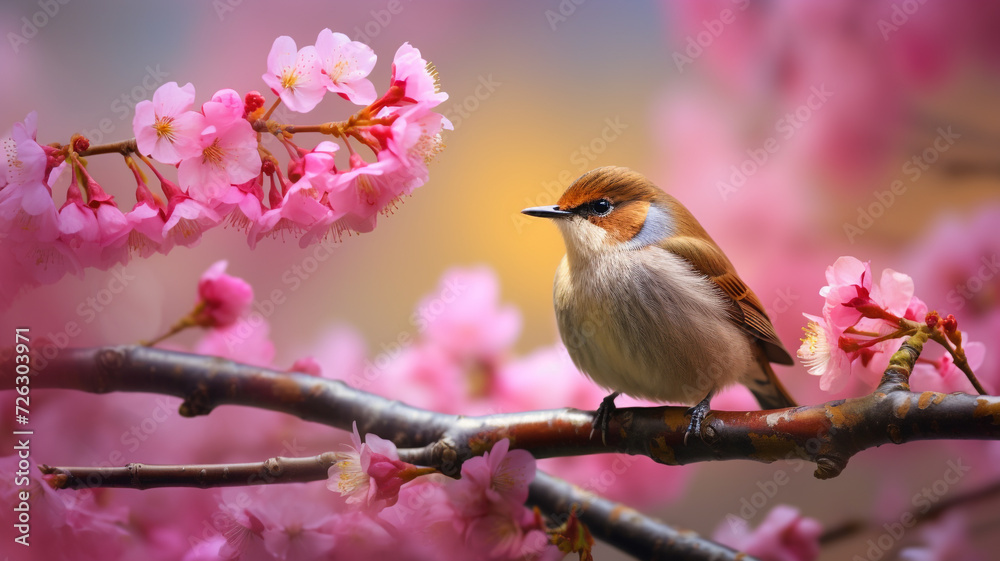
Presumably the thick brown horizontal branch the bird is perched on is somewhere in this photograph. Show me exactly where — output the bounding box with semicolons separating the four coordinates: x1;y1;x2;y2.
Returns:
11;341;1000;478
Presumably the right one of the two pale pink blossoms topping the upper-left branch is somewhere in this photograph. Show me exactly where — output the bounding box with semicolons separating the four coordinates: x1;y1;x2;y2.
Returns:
316;29;376;105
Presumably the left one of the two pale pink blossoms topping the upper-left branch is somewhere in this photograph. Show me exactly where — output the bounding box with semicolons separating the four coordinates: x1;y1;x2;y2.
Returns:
261;35;327;113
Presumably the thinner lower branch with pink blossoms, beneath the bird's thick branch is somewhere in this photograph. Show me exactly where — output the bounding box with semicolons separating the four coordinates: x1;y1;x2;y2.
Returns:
40;442;756;561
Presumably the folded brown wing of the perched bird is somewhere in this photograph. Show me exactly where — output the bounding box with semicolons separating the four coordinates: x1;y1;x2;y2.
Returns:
658;237;795;364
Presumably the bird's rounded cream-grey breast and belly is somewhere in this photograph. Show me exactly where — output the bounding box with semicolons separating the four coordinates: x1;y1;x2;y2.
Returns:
554;245;752;403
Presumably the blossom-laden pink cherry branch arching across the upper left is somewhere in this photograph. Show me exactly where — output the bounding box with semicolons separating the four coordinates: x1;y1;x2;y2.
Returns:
0;29;451;306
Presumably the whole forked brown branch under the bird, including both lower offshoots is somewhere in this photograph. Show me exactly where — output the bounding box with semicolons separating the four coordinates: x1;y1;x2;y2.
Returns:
7;335;1000;559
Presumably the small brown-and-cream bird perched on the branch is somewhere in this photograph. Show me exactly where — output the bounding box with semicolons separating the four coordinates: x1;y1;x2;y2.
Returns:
521;166;795;443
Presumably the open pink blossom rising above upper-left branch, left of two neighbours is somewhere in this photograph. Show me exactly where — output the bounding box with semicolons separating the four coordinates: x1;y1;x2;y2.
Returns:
132;82;201;164
